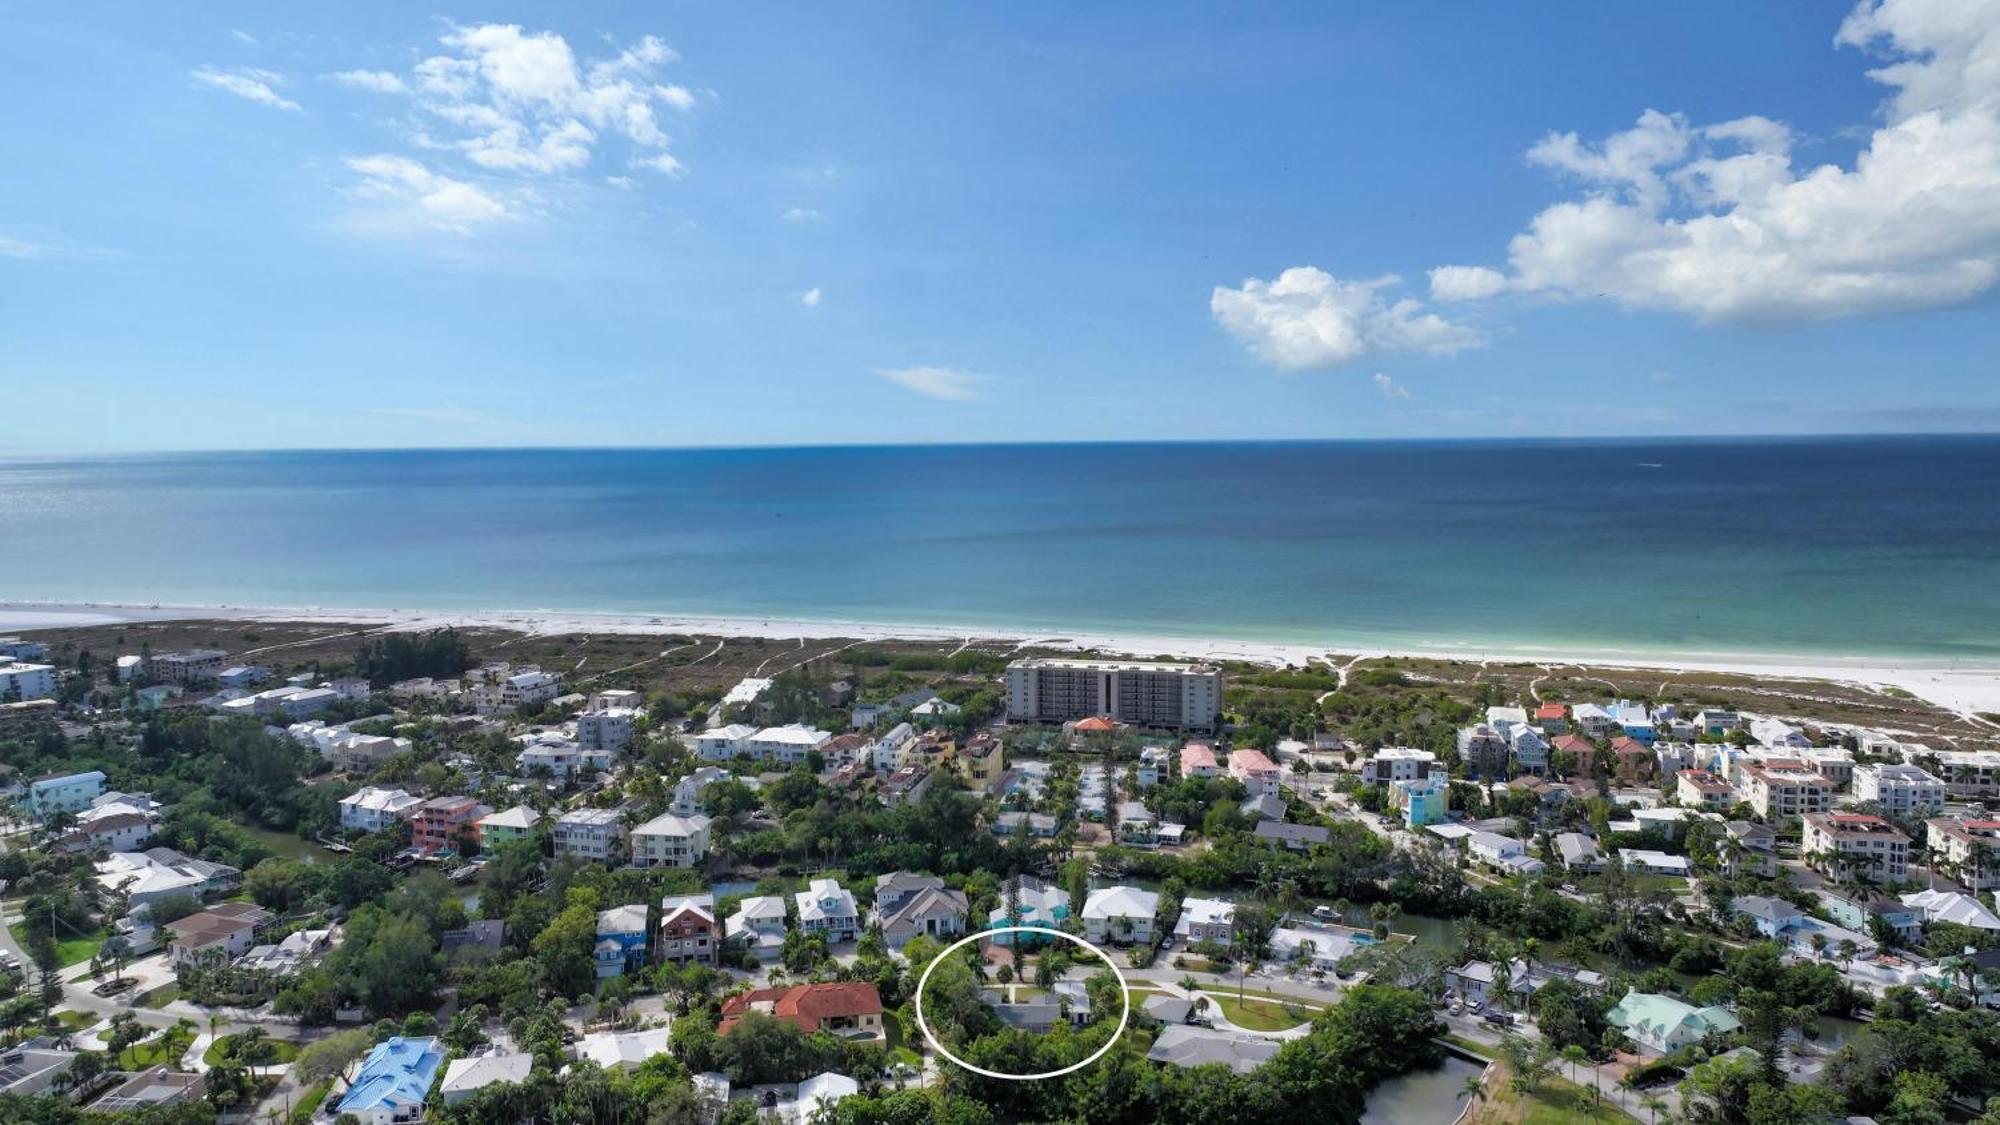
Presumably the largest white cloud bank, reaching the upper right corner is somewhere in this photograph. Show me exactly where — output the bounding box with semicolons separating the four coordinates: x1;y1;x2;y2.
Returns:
1432;0;2000;324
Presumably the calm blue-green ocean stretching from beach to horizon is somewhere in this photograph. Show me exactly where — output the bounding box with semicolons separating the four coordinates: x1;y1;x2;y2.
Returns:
0;436;2000;663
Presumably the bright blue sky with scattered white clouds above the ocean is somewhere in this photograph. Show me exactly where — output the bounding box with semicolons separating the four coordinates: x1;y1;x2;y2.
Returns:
0;0;2000;452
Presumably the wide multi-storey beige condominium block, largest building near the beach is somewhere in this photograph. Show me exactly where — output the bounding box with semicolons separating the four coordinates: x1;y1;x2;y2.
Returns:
1006;657;1222;731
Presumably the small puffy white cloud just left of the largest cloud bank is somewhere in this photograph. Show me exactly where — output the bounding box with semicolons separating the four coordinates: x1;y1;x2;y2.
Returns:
1208;266;1482;370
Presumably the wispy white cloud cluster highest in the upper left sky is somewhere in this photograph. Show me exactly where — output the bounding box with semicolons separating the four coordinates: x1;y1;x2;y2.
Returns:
380;24;694;176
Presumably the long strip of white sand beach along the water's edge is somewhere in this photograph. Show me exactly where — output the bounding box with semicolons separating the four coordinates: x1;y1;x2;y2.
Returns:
0;601;2000;719
